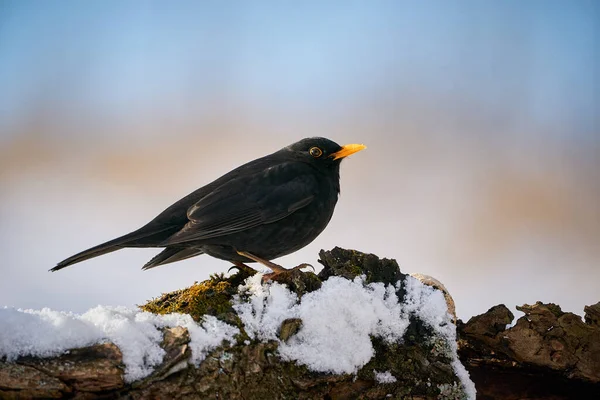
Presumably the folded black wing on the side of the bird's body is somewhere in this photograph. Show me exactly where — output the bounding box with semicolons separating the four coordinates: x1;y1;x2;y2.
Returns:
162;163;318;245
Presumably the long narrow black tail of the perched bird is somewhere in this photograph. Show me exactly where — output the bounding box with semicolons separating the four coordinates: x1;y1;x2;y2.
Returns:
50;227;176;272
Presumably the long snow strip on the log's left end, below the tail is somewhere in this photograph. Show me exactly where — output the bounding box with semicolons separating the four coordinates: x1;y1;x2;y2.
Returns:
0;306;239;382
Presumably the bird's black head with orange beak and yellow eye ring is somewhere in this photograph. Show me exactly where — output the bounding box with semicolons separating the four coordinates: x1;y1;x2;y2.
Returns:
285;137;367;168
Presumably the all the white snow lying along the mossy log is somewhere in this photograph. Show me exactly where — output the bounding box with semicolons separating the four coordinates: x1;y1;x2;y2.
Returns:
0;274;475;399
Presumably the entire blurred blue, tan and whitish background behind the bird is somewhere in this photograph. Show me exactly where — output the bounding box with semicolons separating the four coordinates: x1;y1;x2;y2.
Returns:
0;0;600;319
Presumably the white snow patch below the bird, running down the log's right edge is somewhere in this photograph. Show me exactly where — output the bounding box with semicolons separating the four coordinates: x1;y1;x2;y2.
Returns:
234;274;475;399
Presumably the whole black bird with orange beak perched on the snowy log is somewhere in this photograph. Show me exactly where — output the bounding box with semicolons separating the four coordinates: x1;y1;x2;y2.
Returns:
51;137;365;274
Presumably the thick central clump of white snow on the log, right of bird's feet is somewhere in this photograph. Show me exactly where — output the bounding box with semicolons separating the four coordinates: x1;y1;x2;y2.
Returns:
279;277;408;374
